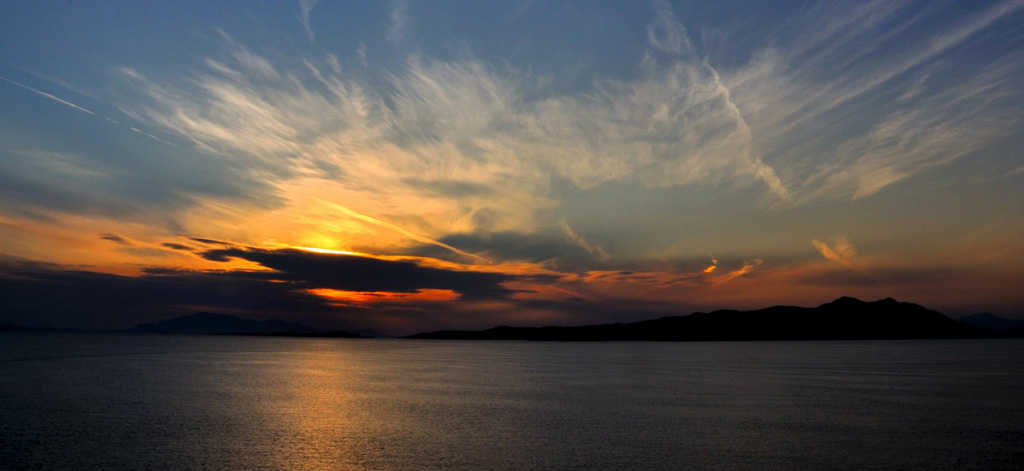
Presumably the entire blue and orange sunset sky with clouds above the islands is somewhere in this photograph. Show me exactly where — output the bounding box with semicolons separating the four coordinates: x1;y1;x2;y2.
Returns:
0;0;1024;334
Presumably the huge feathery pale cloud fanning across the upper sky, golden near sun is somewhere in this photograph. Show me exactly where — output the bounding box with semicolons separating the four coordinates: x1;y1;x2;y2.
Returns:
105;2;1020;273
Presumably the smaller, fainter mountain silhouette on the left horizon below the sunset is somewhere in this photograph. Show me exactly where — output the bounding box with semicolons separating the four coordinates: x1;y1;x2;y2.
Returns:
128;312;324;335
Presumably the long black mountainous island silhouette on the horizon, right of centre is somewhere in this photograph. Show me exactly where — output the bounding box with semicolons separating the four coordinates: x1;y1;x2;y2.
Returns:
409;297;983;342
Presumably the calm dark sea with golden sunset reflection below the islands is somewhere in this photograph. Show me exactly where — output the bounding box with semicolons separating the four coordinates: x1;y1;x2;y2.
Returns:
0;334;1024;470
